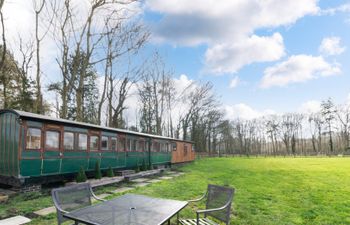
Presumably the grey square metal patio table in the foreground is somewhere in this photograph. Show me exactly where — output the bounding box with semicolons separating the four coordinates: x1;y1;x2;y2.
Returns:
64;194;188;225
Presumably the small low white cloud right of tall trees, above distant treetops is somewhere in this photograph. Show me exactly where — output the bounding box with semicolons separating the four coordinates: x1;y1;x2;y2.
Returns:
223;103;275;120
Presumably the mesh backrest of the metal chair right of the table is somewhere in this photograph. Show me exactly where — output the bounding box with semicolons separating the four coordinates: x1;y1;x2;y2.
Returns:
205;184;235;224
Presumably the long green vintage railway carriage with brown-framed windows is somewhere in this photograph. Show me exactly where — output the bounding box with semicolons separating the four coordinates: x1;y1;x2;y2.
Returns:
0;109;192;186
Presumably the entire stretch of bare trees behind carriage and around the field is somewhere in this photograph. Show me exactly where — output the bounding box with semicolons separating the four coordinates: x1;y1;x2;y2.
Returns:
0;0;350;156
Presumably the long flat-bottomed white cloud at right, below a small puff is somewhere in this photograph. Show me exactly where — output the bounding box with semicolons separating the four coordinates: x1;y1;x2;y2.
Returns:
260;55;341;88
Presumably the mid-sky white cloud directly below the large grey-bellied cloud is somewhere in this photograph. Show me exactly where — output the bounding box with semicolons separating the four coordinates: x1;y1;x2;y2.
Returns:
205;33;285;74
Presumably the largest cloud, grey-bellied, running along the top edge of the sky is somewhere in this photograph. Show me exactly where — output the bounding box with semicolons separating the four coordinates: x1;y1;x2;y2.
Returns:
146;0;319;45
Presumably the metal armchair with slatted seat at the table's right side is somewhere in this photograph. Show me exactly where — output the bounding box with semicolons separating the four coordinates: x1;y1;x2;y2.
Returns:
178;184;235;225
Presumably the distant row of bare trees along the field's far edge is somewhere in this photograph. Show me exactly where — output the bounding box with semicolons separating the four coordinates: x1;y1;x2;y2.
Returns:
216;99;350;156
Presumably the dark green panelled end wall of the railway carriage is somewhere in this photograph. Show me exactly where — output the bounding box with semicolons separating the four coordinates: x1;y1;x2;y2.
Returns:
0;113;20;177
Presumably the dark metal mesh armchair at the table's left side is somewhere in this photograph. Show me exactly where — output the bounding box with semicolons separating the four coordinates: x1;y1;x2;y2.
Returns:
51;183;105;225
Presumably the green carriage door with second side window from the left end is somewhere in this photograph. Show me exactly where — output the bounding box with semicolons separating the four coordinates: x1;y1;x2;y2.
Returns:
41;124;62;175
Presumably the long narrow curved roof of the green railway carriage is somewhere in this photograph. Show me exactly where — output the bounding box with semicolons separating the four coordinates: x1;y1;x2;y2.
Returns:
0;109;193;143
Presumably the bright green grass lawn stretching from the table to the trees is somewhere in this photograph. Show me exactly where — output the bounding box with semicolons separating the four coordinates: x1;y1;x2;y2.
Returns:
0;158;350;225
